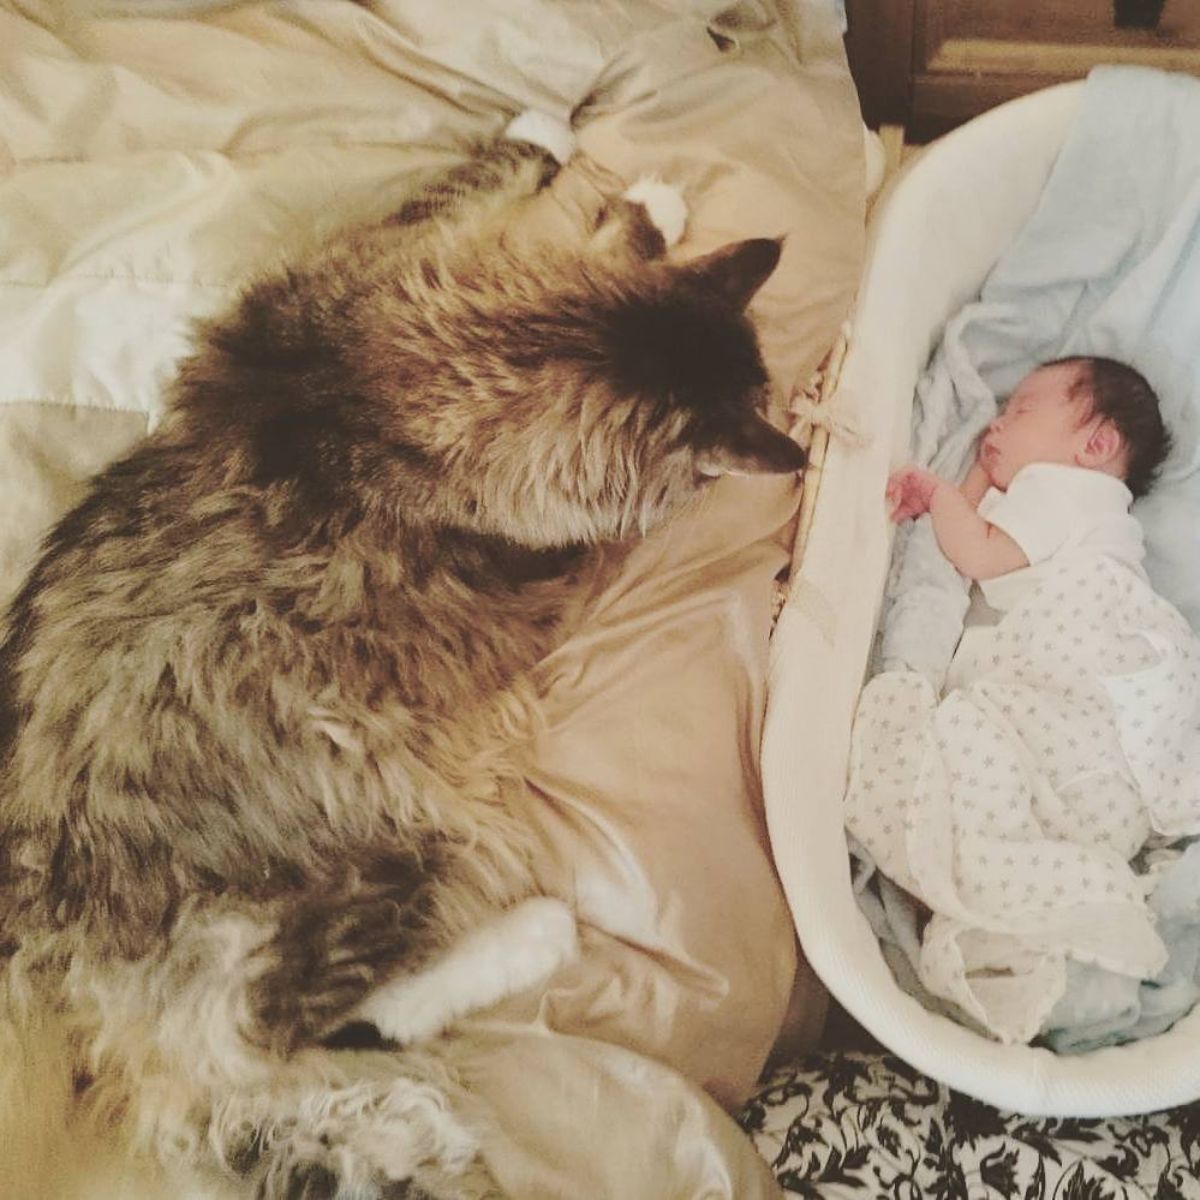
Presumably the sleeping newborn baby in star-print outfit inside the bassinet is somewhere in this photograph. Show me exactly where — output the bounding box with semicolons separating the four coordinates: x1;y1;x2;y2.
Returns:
847;358;1200;1042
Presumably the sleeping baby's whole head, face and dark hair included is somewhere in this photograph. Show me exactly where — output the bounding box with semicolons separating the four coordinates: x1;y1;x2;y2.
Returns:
979;358;1171;497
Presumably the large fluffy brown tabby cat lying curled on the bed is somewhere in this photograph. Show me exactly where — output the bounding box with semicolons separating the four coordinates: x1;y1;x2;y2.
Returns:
0;114;803;1200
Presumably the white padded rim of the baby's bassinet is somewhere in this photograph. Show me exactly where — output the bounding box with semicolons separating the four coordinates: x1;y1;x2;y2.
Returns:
763;84;1200;1116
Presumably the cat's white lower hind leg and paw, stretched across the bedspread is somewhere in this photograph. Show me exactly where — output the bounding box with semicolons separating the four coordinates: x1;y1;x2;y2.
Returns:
355;896;578;1045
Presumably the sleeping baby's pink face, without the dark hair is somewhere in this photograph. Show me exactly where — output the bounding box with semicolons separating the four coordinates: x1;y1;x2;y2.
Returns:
979;362;1091;491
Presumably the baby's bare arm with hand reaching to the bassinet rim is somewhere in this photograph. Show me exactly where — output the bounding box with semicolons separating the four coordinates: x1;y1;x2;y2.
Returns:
887;467;1030;580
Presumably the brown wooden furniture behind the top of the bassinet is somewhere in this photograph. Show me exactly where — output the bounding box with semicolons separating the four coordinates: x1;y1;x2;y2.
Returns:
846;0;1200;142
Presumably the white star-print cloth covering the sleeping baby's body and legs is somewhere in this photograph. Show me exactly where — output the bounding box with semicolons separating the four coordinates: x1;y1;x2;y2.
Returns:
846;554;1200;1042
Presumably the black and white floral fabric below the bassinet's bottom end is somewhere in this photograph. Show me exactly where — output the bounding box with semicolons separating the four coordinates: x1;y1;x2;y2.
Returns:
740;1051;1200;1200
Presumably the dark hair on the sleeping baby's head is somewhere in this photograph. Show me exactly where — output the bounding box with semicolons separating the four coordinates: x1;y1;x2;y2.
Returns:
1043;355;1171;497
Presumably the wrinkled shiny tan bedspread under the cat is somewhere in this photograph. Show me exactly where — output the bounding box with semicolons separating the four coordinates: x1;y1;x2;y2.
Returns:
0;0;863;1200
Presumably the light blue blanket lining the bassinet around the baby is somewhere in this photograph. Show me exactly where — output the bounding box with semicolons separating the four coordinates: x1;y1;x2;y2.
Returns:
869;67;1200;1051
